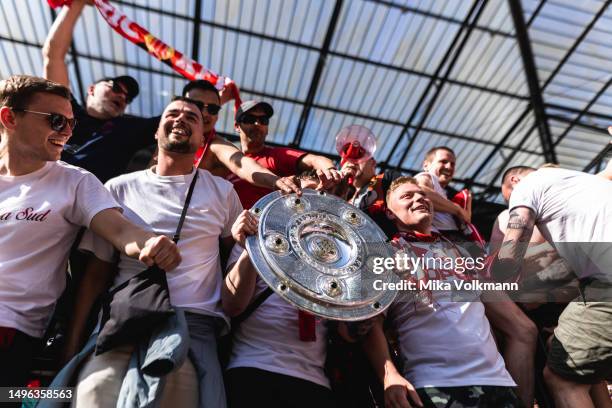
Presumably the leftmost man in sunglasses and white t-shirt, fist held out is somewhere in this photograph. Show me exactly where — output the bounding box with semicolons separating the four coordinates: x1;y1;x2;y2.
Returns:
0;75;180;386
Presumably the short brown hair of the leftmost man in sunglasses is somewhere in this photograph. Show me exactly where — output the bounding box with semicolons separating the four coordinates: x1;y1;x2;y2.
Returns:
0;75;70;109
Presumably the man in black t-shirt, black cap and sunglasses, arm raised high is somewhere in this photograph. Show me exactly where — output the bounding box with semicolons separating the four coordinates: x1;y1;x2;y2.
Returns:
43;0;159;182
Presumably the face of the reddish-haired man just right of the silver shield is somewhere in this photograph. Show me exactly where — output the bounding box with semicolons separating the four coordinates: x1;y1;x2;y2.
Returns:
387;183;433;230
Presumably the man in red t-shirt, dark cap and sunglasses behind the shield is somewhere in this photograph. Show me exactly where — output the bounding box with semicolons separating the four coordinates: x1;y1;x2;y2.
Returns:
228;100;342;208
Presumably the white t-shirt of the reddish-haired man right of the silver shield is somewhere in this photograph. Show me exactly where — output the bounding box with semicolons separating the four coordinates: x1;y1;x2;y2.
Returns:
387;237;515;388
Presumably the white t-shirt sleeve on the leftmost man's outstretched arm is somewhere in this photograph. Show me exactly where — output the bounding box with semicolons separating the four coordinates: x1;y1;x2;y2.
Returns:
67;172;121;228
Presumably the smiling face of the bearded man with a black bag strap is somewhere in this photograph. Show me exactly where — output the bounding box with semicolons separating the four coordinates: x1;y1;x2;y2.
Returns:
155;101;204;154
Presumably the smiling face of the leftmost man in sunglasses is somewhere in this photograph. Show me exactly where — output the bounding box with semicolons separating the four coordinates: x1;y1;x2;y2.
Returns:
6;92;74;162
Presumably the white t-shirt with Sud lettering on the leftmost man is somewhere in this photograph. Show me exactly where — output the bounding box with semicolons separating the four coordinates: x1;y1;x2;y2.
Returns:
0;161;118;337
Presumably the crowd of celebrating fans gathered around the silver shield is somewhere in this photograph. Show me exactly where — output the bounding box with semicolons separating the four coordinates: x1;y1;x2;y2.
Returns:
0;1;612;408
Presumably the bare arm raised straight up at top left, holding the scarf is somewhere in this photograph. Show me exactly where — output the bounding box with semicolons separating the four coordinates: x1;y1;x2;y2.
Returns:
42;0;87;87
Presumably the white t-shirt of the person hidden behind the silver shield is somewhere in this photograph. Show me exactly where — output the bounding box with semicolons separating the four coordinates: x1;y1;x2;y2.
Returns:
228;251;330;388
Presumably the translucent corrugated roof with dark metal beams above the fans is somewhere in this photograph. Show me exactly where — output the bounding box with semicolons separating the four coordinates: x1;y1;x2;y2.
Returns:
0;0;612;201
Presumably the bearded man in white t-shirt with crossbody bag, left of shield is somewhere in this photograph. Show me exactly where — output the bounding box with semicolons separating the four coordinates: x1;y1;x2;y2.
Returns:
68;97;242;408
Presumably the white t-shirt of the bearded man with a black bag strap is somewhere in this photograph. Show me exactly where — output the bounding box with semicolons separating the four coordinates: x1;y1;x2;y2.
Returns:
80;170;242;322
